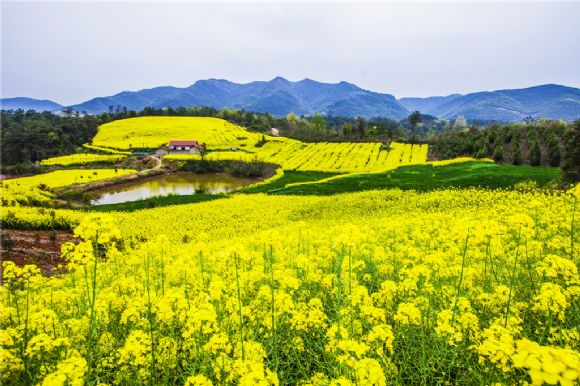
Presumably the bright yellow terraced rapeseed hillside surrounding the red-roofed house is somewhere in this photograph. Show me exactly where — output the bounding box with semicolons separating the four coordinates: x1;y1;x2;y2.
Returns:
93;117;428;173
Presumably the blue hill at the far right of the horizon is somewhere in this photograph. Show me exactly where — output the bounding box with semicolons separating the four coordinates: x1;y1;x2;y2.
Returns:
399;84;580;122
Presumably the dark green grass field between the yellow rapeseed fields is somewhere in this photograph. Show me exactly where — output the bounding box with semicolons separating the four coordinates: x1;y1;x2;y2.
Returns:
260;161;560;195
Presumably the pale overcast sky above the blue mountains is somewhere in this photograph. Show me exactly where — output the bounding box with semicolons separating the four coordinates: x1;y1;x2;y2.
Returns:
1;1;580;104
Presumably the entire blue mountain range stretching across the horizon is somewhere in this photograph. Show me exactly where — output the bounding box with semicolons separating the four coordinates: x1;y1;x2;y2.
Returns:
0;77;580;122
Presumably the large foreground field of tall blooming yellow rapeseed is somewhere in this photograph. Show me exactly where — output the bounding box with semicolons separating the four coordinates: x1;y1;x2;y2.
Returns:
0;189;580;386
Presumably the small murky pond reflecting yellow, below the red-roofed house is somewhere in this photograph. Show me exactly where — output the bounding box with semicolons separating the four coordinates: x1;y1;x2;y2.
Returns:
90;173;259;205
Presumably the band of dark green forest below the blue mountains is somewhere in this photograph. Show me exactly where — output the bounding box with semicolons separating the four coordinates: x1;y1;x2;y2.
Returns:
1;106;580;181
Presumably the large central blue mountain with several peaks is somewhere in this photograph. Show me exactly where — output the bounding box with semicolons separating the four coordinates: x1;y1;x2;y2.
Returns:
72;77;408;119
